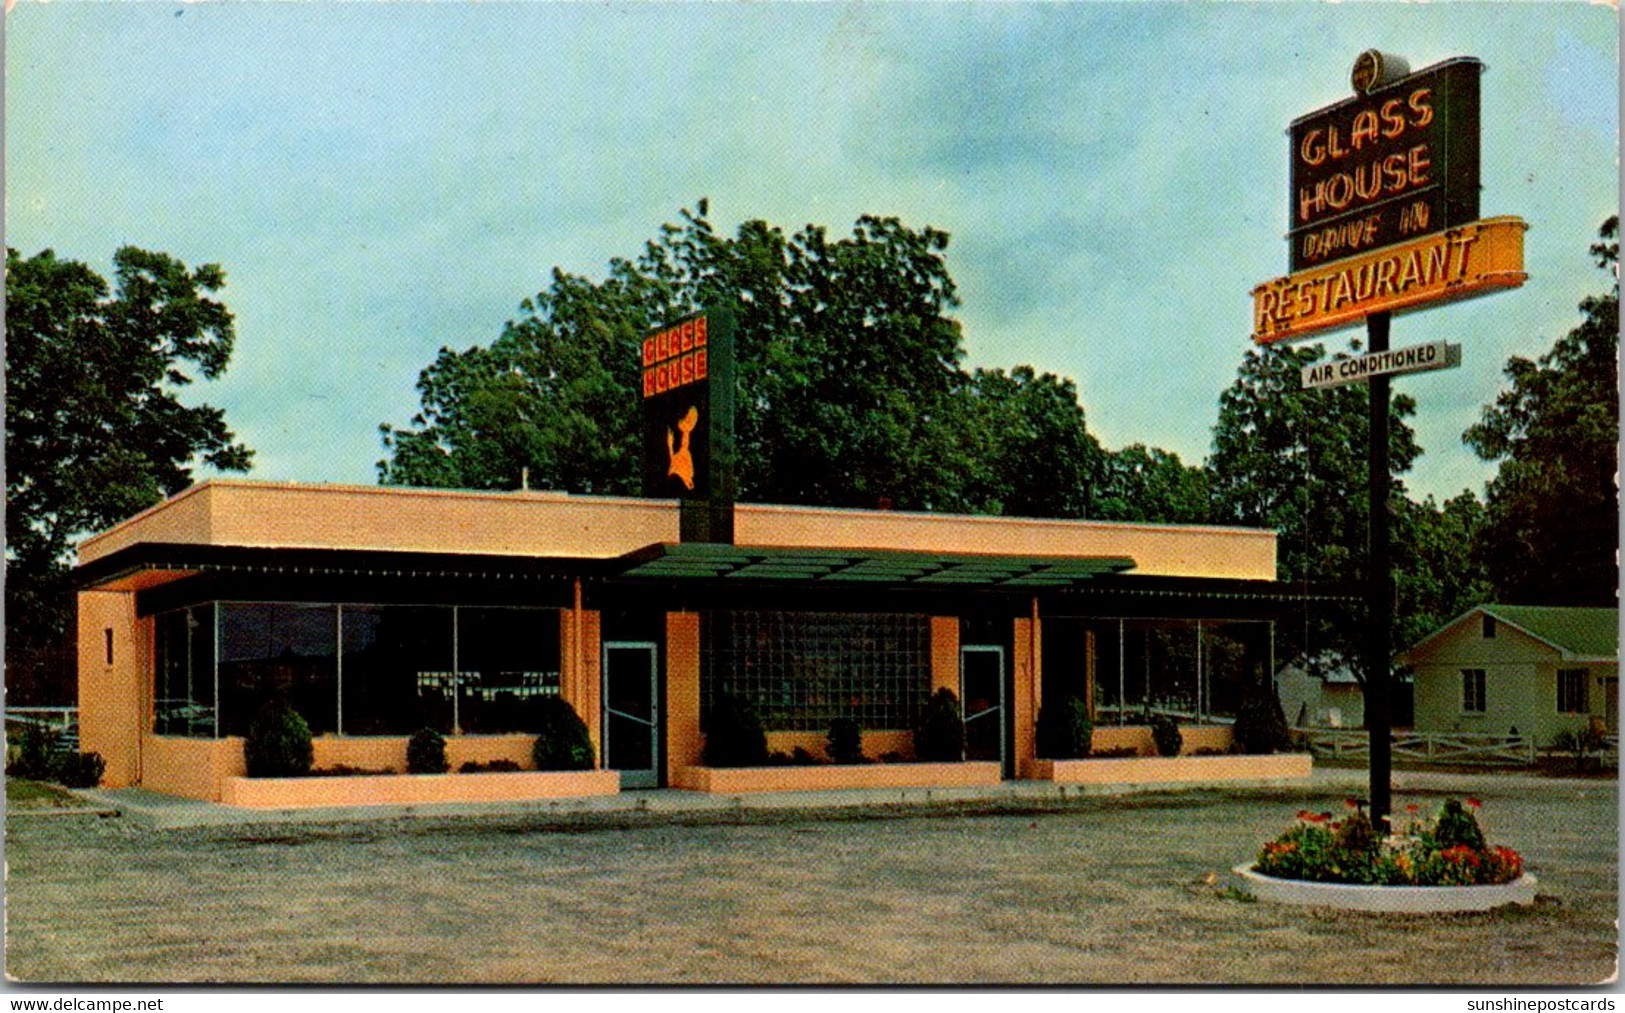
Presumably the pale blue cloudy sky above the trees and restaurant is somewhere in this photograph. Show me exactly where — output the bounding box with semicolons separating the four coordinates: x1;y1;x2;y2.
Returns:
5;0;1619;498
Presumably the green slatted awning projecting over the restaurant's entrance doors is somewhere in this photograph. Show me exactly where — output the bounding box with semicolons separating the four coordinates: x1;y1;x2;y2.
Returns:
616;541;1134;589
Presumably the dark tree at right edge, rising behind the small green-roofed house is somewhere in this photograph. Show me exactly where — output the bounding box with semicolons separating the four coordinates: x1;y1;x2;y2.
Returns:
1463;216;1620;606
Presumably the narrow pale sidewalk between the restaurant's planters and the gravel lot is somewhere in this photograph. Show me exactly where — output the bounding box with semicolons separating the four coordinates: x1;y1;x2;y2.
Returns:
60;767;1586;829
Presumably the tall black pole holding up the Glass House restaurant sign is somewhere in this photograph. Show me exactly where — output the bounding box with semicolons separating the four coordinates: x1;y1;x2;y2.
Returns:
1365;311;1394;833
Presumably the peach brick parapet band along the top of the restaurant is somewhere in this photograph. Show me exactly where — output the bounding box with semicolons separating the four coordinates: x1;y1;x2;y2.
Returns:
80;480;1276;580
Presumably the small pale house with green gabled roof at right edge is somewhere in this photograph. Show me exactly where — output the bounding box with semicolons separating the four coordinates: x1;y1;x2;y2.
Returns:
1398;605;1619;746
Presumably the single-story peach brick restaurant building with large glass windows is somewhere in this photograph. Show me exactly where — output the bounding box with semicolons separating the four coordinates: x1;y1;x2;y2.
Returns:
76;480;1332;800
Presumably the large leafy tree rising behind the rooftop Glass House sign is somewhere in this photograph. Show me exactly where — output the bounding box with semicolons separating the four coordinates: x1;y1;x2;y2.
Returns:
379;202;977;509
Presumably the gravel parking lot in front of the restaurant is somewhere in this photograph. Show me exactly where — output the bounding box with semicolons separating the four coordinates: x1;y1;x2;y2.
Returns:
7;776;1619;985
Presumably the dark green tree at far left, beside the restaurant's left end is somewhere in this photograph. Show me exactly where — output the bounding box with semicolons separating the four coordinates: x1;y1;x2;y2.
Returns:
5;247;252;702
